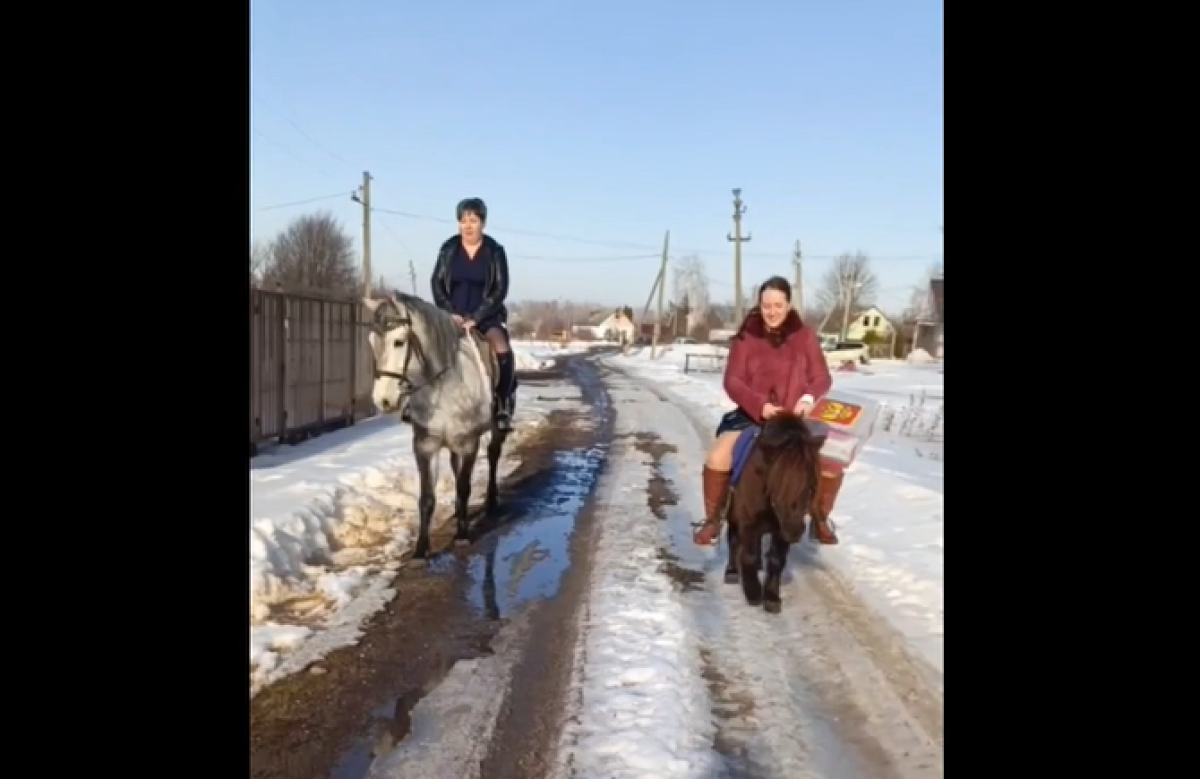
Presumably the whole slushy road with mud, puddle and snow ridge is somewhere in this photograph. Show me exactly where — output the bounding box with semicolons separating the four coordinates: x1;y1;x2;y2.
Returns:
251;356;943;779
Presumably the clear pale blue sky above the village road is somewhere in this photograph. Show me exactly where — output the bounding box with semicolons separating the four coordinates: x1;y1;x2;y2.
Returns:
251;0;944;308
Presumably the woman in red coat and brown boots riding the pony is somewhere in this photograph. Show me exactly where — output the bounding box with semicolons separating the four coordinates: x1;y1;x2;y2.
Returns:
695;276;841;545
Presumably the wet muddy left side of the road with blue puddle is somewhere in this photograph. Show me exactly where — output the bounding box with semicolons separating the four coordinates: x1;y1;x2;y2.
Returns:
250;356;612;779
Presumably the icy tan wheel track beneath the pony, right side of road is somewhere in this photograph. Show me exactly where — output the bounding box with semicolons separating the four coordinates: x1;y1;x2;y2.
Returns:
604;368;944;779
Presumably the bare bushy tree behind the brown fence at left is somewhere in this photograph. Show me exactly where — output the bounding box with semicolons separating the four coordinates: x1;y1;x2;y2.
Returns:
263;211;362;298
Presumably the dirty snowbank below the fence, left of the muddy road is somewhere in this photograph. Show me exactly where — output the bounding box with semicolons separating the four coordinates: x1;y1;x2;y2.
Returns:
250;403;556;691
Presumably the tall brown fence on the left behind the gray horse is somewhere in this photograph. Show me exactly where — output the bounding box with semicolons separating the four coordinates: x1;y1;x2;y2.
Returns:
250;289;374;456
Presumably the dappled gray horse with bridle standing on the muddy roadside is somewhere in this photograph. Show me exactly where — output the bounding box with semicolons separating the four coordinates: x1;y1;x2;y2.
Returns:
364;292;508;559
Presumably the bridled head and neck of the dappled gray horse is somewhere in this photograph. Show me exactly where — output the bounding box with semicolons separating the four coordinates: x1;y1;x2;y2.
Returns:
362;292;460;413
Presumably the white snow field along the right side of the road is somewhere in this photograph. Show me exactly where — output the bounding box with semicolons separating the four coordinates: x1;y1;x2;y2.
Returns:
607;346;944;670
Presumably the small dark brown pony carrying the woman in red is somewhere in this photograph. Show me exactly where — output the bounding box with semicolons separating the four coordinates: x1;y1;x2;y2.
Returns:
725;413;827;615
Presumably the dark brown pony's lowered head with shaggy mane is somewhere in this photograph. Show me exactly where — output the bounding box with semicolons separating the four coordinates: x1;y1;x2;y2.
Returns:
757;413;824;544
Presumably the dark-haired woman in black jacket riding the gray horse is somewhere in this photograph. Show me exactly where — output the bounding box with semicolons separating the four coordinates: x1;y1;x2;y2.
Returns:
431;198;516;431
